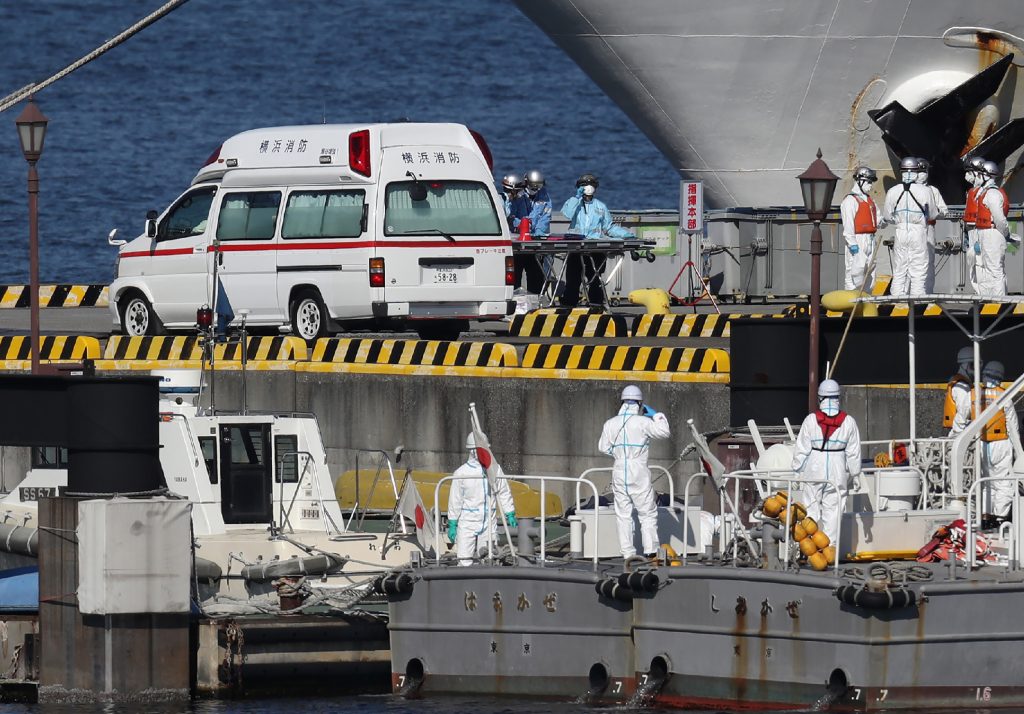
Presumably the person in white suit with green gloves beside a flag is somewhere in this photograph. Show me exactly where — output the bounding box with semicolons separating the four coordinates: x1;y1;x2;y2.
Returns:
449;431;519;565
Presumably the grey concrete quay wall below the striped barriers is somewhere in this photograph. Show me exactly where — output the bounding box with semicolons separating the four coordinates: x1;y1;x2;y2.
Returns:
209;372;729;505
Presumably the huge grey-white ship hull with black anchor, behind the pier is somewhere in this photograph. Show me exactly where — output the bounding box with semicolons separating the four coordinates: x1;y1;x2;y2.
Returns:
515;0;1024;208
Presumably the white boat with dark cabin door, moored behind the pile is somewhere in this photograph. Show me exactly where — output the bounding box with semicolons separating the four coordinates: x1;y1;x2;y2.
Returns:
0;370;418;600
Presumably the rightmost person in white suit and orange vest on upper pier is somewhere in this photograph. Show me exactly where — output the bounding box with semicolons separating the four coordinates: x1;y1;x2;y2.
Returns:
974;161;1017;295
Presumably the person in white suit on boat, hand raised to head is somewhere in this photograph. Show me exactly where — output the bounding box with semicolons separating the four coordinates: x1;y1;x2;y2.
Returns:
597;384;671;558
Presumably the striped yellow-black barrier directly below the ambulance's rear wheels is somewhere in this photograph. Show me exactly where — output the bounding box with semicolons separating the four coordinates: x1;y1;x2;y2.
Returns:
310;338;519;367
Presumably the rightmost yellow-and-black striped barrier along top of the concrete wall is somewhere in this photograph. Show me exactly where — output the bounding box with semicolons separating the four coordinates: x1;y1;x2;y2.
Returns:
522;344;729;374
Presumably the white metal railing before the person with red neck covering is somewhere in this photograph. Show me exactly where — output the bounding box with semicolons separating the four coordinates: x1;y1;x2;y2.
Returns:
682;469;843;569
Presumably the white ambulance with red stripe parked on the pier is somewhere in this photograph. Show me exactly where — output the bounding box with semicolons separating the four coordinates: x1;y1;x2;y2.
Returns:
110;123;515;339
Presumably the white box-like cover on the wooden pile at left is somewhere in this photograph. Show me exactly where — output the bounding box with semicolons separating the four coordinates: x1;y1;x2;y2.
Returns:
78;498;191;615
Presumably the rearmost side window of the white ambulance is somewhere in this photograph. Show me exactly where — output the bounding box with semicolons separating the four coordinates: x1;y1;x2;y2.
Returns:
281;188;367;240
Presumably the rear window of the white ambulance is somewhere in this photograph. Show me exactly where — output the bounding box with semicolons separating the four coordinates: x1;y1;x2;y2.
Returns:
384;179;502;236
